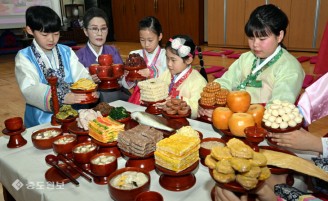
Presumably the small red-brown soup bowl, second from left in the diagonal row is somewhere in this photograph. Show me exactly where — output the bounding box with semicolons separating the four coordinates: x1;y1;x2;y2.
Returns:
52;134;77;154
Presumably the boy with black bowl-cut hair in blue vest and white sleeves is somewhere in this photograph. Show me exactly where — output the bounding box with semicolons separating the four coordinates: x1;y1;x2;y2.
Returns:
15;6;92;128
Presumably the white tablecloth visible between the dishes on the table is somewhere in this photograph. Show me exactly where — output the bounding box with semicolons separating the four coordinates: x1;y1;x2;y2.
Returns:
0;101;316;201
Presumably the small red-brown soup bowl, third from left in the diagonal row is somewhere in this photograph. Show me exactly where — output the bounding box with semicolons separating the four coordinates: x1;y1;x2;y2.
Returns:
72;142;98;164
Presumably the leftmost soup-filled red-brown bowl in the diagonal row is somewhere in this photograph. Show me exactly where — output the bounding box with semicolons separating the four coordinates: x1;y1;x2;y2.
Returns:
31;128;63;149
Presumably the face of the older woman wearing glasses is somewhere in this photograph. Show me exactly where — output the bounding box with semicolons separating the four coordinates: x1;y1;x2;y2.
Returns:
83;17;108;49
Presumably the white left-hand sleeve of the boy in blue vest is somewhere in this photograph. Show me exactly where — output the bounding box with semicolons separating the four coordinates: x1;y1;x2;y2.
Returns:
15;53;51;111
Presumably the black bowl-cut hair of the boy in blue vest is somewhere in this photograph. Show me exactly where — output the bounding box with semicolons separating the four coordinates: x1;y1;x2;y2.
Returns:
25;6;61;33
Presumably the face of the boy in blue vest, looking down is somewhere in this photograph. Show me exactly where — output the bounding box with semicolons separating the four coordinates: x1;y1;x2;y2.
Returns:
26;28;60;51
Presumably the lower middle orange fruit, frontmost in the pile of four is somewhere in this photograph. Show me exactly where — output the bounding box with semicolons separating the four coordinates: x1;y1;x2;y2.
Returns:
228;112;255;137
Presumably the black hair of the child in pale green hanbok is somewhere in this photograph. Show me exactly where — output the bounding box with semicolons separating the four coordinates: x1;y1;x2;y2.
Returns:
245;4;288;48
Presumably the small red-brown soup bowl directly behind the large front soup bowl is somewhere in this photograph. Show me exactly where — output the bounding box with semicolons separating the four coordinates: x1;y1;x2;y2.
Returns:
90;152;117;176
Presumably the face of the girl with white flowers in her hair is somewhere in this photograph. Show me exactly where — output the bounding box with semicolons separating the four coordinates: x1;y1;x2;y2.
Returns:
166;48;193;75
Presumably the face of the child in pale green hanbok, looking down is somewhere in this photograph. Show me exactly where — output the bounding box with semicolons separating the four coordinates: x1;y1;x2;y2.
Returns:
248;31;284;59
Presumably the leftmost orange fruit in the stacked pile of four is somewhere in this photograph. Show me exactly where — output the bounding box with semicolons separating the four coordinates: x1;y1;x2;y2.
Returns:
212;107;233;130
